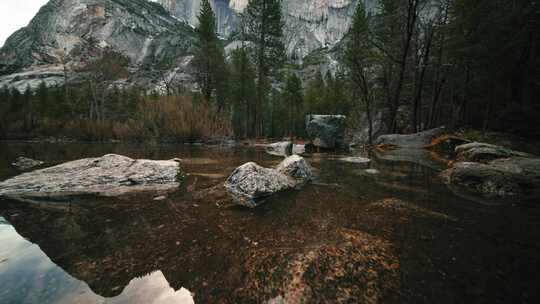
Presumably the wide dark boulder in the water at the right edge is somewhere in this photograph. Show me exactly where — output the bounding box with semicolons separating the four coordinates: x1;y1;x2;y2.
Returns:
443;157;540;200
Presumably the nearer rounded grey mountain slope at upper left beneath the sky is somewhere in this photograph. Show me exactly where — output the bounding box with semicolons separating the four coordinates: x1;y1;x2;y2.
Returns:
0;0;193;87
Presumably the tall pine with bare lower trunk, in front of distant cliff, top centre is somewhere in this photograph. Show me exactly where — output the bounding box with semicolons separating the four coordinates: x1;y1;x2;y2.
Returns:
241;0;285;136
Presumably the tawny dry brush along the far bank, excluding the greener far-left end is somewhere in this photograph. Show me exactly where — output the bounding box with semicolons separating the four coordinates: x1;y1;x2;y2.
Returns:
57;96;232;142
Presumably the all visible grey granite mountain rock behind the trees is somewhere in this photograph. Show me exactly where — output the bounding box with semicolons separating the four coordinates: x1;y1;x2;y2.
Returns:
0;0;376;91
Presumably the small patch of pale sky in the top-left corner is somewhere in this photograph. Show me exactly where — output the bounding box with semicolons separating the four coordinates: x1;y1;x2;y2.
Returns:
0;0;47;46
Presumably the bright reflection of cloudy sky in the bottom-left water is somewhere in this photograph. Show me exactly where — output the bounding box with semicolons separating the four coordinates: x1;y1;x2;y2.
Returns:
0;217;193;304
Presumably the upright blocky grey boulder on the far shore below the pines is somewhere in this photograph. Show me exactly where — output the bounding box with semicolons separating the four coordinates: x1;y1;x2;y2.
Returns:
306;115;347;149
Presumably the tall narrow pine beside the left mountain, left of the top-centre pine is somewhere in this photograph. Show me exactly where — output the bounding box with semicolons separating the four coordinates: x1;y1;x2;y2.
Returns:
193;0;227;110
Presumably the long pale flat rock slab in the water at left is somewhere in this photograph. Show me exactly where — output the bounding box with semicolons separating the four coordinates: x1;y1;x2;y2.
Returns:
0;154;180;199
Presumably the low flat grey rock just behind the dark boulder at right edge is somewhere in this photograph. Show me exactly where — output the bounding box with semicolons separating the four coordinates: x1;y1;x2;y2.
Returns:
455;142;531;163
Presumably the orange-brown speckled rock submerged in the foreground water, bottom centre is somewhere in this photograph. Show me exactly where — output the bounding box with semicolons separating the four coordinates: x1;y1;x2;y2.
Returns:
236;228;400;304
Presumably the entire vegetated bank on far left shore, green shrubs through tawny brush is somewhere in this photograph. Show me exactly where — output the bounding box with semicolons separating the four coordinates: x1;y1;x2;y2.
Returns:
0;89;232;142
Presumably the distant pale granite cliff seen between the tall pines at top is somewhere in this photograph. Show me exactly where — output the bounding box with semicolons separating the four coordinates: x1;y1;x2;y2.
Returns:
158;0;376;59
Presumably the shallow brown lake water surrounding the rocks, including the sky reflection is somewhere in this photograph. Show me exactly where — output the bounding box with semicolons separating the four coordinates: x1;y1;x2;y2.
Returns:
0;142;540;303
